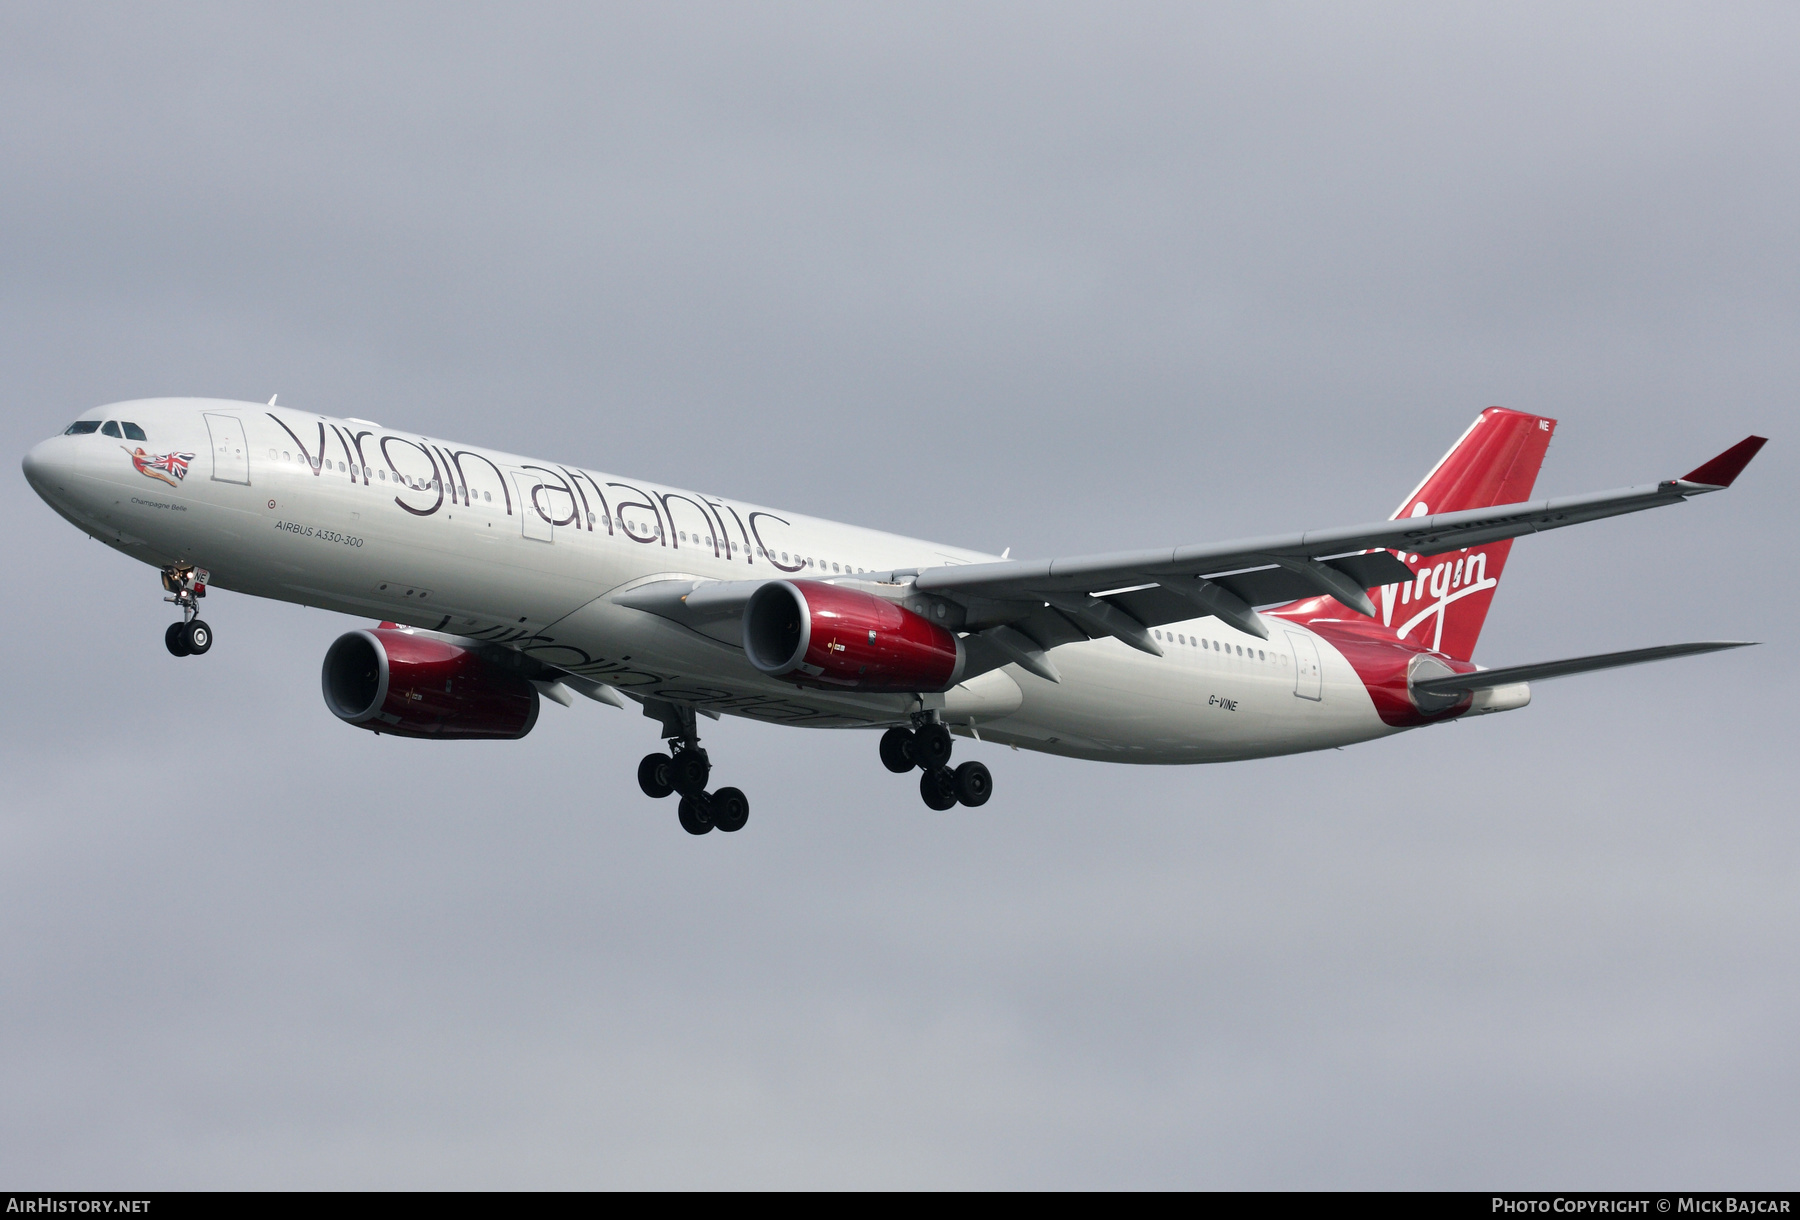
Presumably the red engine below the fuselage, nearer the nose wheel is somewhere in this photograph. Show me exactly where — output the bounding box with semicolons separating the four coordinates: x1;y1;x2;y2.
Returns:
320;626;538;740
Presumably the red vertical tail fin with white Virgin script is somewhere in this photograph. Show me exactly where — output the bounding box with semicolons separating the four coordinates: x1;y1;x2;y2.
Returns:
1370;407;1557;660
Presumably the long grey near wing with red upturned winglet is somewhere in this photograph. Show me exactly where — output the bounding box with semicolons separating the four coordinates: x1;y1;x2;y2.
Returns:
880;437;1764;658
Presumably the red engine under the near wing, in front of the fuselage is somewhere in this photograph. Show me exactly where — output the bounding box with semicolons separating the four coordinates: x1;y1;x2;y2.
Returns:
743;581;965;693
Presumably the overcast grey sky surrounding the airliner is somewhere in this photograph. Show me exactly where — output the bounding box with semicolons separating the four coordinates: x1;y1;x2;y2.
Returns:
0;2;1800;1189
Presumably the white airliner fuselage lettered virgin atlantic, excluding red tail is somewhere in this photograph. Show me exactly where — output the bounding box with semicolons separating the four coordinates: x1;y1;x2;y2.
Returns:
25;399;1397;763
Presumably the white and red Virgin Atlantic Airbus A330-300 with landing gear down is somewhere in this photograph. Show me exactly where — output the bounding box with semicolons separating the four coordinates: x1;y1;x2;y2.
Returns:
23;398;1764;835
